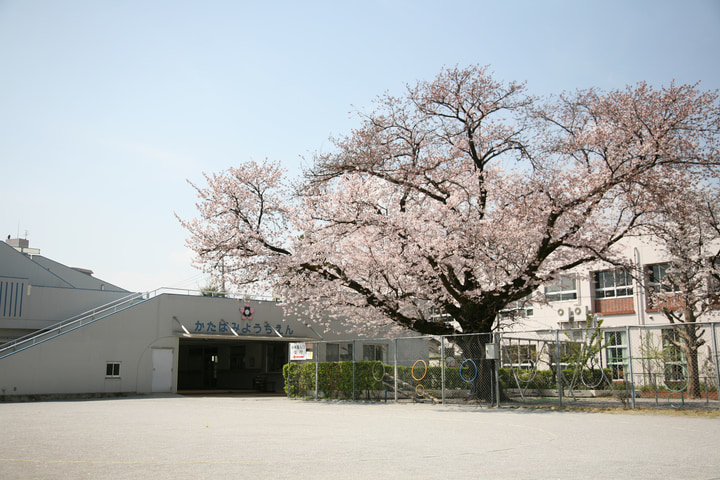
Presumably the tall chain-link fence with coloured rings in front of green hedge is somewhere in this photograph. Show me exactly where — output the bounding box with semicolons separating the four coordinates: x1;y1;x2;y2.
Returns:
284;323;720;408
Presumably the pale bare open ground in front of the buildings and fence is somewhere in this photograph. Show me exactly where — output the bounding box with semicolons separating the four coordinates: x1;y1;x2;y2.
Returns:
0;396;720;480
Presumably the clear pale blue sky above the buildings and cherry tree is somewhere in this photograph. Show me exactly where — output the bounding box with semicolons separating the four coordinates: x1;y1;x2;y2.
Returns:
0;0;720;291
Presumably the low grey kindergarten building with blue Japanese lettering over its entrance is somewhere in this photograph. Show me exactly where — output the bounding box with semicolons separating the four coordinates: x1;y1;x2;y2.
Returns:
0;238;408;399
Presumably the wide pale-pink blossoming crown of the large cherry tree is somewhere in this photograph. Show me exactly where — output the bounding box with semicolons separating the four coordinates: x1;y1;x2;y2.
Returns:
182;67;720;342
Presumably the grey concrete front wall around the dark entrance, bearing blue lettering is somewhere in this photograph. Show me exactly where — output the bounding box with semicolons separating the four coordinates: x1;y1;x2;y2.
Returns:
0;294;332;397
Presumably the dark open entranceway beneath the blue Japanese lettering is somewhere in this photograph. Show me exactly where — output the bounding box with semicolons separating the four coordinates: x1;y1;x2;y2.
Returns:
178;339;288;393
